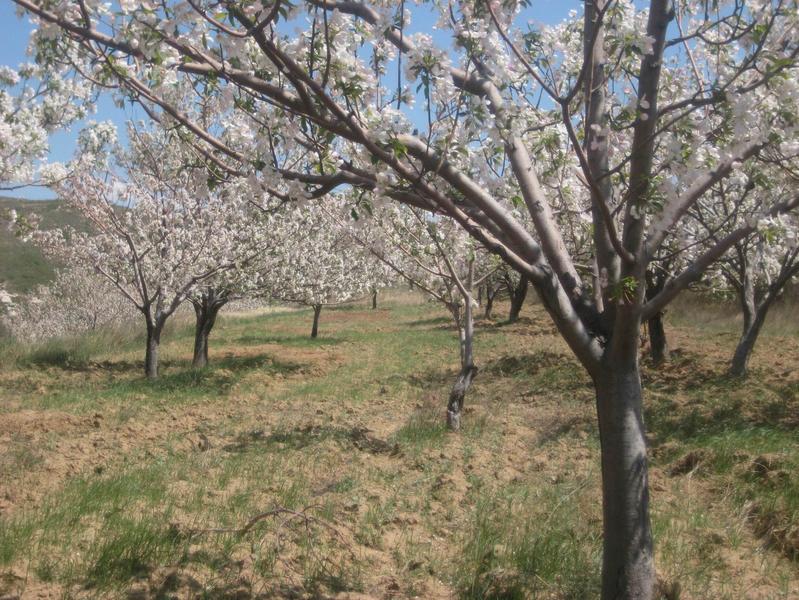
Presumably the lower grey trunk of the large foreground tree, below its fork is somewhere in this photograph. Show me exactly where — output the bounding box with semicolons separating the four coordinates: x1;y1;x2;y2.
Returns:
594;354;655;600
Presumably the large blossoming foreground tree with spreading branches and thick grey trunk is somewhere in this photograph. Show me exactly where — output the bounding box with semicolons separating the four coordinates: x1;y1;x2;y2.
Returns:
14;0;799;599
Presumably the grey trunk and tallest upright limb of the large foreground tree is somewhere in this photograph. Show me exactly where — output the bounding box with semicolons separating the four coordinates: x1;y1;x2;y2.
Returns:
586;0;674;600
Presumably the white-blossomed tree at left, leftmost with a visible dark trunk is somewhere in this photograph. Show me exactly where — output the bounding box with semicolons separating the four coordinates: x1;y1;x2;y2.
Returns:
34;129;268;378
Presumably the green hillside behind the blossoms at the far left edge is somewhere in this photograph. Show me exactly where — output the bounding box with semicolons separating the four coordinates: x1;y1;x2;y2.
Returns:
0;198;86;293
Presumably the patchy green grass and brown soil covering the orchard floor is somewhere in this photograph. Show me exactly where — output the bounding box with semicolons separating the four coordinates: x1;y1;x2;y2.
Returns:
0;296;799;599
